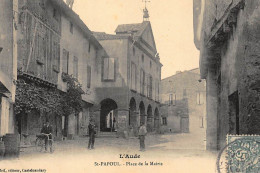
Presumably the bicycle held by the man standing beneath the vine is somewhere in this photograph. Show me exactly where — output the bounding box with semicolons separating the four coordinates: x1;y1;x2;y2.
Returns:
35;134;54;153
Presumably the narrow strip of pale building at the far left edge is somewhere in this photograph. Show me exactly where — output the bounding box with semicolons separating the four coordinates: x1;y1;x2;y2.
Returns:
0;0;18;136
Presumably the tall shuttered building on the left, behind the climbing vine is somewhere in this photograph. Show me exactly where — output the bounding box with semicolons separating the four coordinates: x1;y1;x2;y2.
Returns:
12;0;107;144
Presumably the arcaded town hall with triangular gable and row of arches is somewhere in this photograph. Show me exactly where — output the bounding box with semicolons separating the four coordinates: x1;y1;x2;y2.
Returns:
94;21;162;135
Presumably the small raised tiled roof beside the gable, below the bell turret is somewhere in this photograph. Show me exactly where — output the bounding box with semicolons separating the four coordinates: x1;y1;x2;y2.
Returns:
115;21;149;36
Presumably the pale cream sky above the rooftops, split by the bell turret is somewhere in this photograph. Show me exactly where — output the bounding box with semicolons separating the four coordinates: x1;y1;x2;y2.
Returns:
73;0;199;79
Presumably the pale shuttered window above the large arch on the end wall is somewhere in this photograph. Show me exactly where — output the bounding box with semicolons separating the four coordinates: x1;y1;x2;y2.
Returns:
103;58;115;80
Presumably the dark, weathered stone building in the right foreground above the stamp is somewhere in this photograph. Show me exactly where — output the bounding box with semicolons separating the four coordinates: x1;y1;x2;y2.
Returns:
194;0;260;149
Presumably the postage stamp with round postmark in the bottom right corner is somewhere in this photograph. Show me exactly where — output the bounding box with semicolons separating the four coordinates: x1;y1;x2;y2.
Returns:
218;135;260;173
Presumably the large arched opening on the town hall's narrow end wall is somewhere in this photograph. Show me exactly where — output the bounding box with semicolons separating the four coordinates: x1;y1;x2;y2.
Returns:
100;99;117;132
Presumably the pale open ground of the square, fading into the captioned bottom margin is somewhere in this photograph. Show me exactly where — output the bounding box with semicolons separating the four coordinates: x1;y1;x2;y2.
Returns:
0;134;217;173
